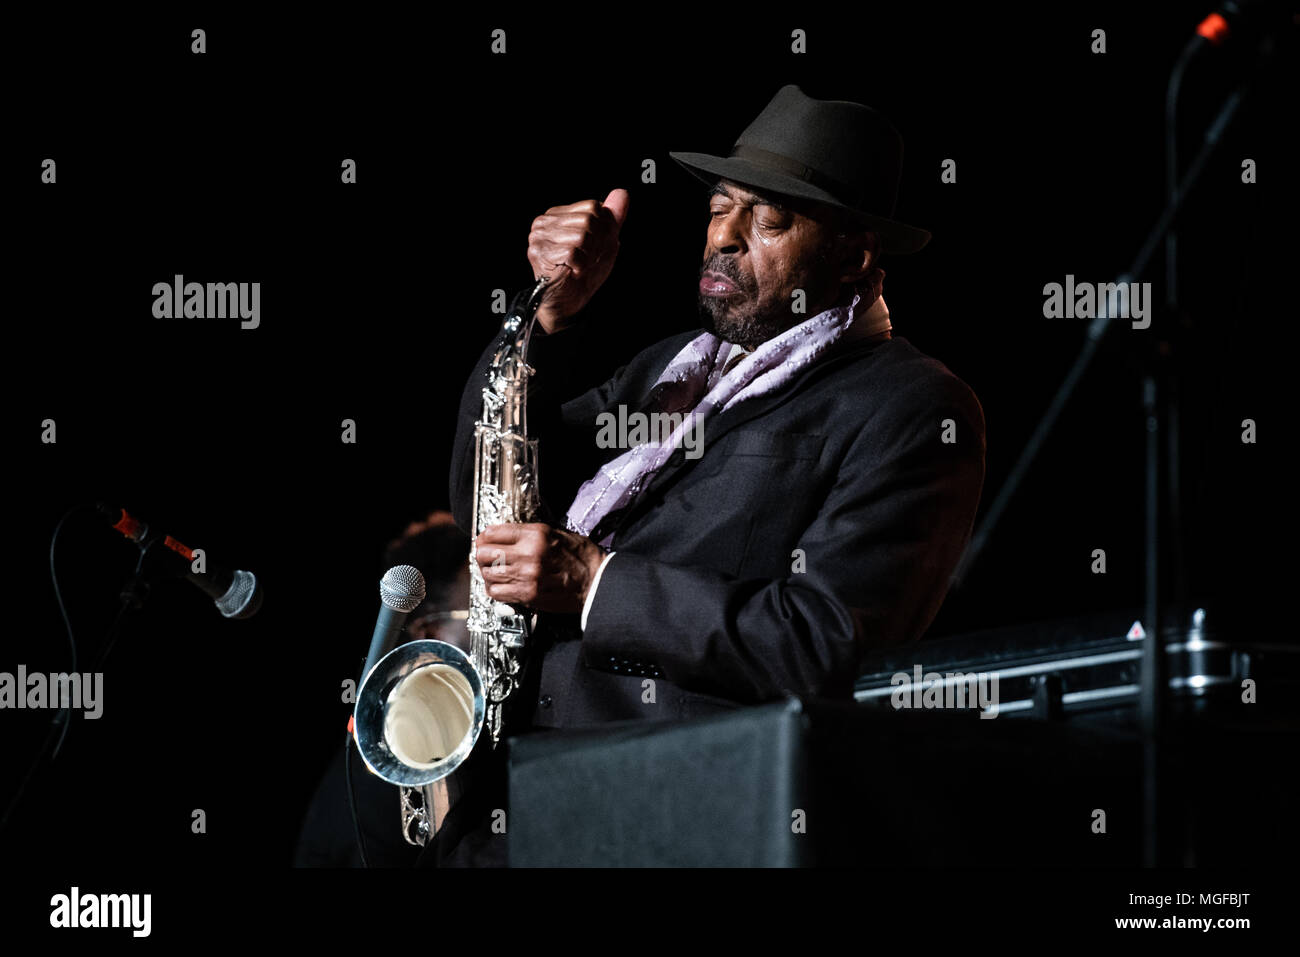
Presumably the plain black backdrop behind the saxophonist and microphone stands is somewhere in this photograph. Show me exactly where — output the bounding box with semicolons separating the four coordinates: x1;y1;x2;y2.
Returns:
0;3;1296;910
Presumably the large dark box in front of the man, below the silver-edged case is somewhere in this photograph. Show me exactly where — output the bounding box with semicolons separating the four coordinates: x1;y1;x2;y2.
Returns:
508;698;1140;867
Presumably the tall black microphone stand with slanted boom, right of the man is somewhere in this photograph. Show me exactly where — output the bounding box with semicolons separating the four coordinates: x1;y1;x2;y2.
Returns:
949;36;1274;867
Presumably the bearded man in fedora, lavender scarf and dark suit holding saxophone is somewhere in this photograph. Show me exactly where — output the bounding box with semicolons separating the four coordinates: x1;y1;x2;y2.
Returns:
439;86;984;858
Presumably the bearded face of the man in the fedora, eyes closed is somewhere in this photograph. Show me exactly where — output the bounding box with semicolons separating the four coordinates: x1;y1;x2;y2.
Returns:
699;179;840;348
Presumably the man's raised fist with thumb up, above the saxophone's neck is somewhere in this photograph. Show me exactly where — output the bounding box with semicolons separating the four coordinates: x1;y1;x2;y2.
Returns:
528;190;628;333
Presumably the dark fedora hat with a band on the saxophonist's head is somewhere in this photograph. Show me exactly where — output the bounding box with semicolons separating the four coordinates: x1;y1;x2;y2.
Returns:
668;83;930;252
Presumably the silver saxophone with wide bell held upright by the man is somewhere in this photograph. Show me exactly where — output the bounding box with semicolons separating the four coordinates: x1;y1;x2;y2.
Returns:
352;278;549;845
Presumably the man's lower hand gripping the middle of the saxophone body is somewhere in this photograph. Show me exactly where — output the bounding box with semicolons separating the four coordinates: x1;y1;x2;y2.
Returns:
475;523;606;612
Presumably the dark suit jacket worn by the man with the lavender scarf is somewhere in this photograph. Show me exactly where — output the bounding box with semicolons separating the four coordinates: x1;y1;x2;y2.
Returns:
451;302;984;732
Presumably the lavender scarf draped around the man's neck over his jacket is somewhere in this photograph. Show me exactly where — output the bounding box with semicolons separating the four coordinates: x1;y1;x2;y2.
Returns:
568;293;888;545
